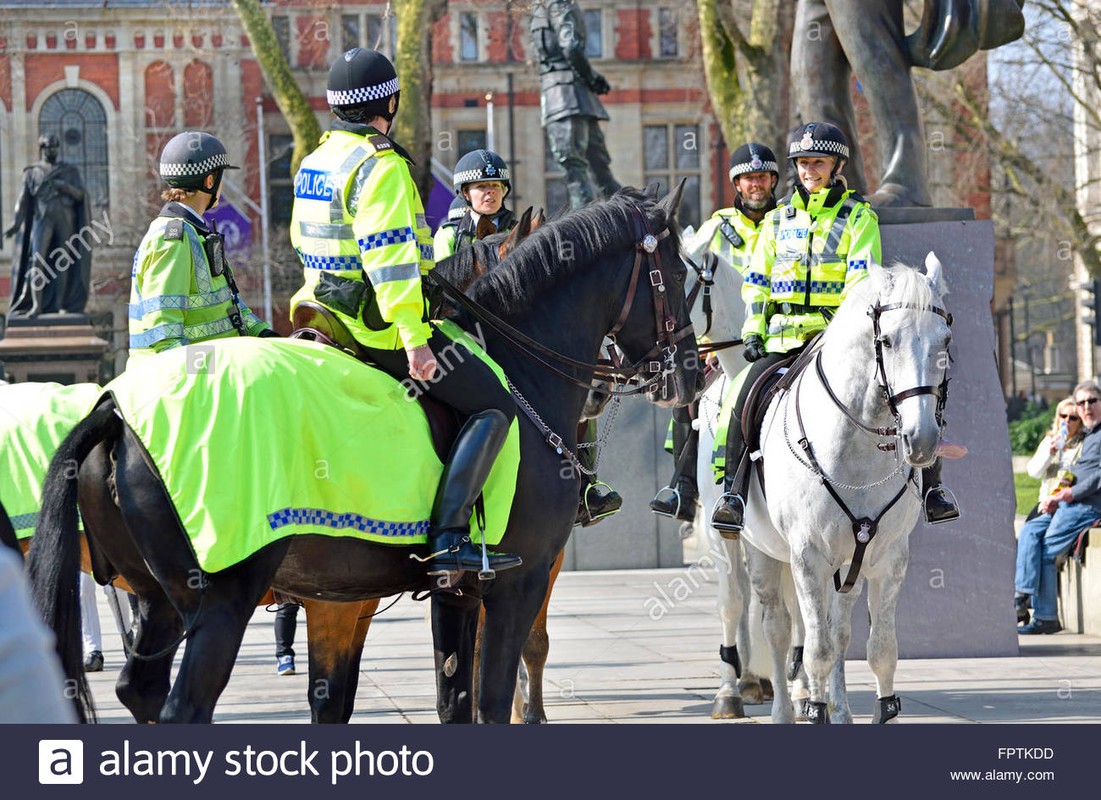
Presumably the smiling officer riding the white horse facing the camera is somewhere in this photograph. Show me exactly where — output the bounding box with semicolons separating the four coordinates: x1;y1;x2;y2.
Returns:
711;122;959;536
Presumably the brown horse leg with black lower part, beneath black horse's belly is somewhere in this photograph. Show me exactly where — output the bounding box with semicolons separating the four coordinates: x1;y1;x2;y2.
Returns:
302;598;379;723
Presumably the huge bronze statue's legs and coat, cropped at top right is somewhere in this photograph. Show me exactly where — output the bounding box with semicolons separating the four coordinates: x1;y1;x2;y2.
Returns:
792;0;1024;207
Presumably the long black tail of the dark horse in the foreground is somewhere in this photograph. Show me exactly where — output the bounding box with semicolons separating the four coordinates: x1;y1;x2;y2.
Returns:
26;403;122;722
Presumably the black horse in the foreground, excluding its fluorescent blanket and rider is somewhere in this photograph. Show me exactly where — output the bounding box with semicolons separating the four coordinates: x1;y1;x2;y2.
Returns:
29;191;699;722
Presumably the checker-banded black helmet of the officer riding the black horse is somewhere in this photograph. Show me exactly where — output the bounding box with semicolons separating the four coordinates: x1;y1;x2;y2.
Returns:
325;47;401;122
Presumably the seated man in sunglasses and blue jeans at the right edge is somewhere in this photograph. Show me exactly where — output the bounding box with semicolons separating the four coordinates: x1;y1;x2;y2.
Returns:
1014;381;1101;634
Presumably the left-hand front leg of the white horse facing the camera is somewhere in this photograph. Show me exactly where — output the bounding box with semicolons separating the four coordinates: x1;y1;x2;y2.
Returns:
785;545;833;723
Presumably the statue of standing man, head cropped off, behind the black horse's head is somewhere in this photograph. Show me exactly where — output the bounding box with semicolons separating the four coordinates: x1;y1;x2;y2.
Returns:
532;0;620;208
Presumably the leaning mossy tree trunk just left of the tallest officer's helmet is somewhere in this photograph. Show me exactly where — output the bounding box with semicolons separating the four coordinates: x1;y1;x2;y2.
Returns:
232;0;321;178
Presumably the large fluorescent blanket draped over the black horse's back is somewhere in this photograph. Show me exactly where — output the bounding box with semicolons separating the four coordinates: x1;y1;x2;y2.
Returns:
105;324;520;572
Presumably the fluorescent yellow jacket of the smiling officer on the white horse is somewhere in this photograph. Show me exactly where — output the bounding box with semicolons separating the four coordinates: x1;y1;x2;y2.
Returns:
742;186;881;353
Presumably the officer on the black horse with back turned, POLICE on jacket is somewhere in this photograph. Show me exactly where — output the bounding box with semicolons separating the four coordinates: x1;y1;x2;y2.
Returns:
291;47;521;574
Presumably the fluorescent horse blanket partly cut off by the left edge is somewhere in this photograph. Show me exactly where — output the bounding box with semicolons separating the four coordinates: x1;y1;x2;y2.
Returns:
0;382;102;539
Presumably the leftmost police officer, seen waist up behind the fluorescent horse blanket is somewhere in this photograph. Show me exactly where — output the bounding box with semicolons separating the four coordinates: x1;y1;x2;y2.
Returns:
129;131;276;360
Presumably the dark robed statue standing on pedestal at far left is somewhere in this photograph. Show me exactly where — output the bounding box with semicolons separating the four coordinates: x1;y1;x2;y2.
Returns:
4;134;91;317
